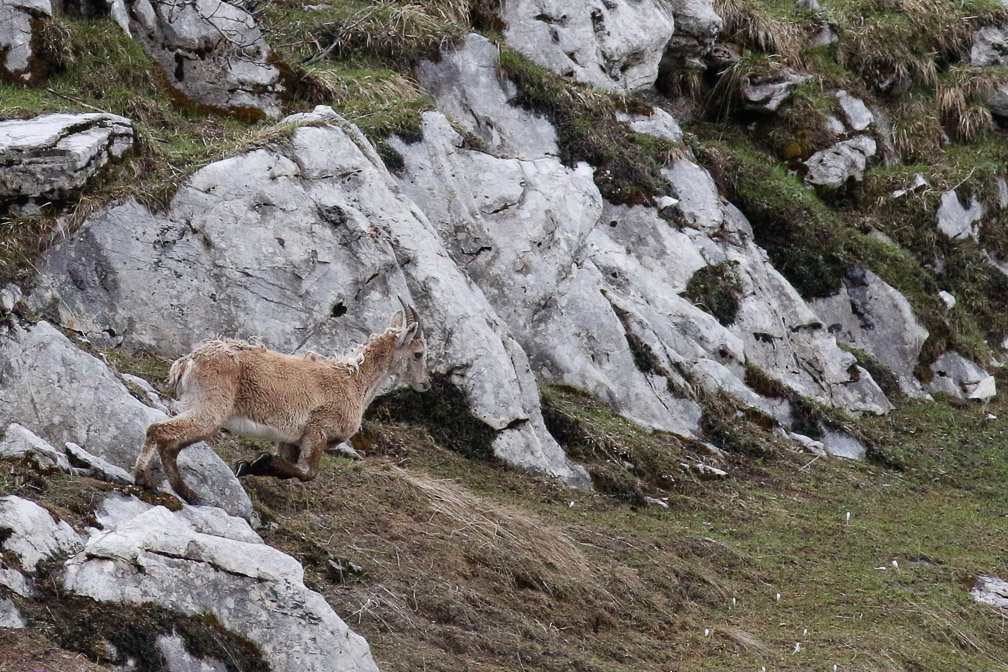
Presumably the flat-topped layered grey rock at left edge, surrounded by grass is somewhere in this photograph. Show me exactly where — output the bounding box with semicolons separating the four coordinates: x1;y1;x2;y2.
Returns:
0;112;133;205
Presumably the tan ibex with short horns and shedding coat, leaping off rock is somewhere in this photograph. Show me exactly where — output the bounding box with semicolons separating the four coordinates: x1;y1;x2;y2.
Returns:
134;299;430;504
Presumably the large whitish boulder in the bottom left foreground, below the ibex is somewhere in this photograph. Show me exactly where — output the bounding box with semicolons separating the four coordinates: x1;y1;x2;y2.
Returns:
64;500;378;672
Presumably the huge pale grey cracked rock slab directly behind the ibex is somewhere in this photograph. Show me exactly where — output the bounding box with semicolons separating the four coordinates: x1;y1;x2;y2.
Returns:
30;103;587;483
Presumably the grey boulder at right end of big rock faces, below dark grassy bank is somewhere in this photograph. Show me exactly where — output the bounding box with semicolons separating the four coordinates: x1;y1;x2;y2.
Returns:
809;269;928;397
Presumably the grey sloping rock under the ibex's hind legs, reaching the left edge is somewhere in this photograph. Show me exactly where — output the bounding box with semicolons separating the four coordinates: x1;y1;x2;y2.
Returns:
0;322;257;520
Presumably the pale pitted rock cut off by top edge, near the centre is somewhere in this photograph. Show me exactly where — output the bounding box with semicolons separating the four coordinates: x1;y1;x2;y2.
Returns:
501;0;674;93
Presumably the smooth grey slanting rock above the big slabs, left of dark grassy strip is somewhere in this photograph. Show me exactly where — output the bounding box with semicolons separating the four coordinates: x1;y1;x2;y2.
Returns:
416;33;559;158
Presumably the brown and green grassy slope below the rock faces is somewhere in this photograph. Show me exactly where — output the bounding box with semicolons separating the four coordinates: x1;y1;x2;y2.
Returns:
0;378;991;671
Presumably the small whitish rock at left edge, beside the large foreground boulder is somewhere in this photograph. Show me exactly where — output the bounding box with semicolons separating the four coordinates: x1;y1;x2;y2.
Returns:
0;495;82;573
